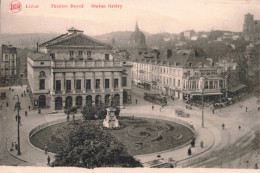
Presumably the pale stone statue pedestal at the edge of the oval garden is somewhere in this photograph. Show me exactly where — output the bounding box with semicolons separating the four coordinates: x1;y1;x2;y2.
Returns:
103;107;119;129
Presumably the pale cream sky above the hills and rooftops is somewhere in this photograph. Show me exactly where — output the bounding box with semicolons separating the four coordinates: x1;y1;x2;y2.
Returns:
1;0;260;35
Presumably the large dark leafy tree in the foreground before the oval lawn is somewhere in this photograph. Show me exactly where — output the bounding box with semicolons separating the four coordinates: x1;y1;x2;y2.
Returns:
52;123;142;168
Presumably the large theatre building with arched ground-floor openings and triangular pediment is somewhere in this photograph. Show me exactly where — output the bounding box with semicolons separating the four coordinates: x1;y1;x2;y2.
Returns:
27;28;131;110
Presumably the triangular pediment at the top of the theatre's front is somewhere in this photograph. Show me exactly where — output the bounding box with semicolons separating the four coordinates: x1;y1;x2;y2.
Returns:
49;34;110;47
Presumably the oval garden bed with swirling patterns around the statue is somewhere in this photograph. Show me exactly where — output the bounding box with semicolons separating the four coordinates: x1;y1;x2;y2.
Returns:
30;117;195;156
